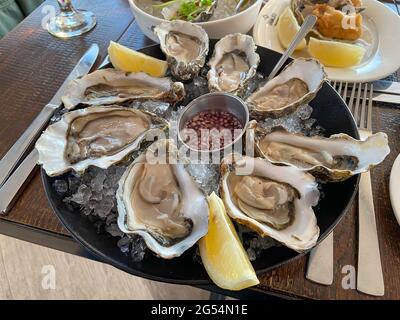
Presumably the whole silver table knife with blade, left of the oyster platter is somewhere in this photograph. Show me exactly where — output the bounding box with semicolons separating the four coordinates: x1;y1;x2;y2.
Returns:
0;44;99;187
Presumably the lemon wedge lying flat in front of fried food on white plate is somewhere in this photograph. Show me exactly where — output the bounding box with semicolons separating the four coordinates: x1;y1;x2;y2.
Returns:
308;38;365;68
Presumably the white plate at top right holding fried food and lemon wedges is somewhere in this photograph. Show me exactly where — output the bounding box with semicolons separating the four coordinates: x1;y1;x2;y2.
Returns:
253;0;400;82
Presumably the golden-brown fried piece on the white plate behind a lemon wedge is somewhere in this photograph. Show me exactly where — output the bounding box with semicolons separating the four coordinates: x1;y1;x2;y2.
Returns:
312;0;362;41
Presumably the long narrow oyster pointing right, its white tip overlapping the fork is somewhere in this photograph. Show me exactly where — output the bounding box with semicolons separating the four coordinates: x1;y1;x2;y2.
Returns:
250;123;390;181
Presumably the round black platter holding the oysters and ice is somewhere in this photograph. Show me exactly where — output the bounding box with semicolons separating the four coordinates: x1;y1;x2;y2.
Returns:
42;41;359;285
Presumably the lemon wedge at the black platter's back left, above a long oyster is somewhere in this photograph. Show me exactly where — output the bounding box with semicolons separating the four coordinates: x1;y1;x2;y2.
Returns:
108;41;168;77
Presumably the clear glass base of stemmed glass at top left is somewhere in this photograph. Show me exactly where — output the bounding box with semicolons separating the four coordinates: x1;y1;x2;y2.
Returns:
47;0;96;38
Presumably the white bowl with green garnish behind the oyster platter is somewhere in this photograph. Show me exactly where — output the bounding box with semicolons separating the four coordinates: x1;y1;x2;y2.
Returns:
129;0;262;42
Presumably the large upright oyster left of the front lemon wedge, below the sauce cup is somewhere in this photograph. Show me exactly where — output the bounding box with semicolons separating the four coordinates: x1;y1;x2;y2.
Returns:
116;140;208;259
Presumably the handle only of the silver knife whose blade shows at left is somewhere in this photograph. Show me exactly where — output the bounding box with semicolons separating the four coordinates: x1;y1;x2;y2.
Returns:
0;104;58;187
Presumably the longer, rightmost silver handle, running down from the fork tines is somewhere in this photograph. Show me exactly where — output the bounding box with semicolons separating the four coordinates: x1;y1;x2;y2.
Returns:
357;172;385;296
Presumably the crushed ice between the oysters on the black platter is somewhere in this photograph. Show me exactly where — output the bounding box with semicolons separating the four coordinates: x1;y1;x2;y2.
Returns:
51;67;323;264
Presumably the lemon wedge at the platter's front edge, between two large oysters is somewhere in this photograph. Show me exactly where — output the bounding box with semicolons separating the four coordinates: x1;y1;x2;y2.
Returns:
199;193;260;290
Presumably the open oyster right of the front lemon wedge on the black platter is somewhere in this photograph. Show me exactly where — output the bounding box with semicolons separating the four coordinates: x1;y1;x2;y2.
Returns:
220;155;319;252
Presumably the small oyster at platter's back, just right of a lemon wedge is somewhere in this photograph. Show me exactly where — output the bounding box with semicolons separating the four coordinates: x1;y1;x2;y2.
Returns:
154;20;209;81
